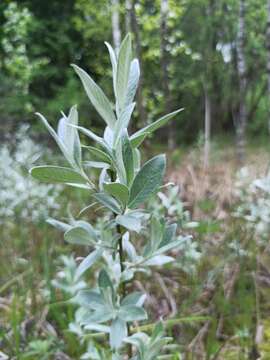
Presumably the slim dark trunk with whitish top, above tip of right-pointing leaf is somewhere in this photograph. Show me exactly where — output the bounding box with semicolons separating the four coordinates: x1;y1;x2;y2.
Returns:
160;0;175;150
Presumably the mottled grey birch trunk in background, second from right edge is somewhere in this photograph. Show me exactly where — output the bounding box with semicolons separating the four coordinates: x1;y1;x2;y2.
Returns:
236;0;247;163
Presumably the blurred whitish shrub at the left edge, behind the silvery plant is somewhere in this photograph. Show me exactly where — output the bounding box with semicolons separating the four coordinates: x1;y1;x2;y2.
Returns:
0;126;61;224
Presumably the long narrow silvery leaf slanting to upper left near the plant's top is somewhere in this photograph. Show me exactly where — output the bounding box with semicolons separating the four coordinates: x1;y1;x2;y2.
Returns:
72;65;116;129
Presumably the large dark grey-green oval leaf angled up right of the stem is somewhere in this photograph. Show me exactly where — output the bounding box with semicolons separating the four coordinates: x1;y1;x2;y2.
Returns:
128;155;166;209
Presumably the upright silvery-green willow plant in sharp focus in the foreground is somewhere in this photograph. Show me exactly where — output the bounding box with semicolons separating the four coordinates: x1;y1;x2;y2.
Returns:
30;34;185;360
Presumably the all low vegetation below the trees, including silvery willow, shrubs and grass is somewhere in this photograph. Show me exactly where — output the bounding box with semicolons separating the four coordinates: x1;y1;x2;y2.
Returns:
0;35;270;360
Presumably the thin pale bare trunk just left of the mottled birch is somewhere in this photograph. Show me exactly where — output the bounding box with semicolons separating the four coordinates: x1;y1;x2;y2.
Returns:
203;86;211;169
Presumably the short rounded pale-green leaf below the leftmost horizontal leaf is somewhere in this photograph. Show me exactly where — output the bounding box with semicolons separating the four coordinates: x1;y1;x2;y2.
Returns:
64;221;97;245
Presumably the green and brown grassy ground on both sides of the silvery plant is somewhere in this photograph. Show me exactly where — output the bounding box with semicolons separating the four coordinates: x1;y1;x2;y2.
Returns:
0;141;270;360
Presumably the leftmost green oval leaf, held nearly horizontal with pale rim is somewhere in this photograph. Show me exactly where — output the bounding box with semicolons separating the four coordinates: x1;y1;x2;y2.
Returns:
30;165;86;184
